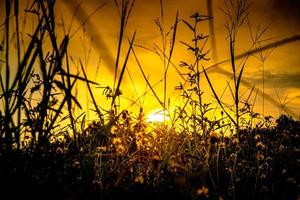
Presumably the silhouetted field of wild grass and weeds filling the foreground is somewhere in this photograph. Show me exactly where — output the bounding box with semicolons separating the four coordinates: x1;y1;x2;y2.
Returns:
0;0;300;200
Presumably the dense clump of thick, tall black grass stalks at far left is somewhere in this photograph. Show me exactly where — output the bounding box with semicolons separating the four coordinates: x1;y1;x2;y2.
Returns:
0;0;99;150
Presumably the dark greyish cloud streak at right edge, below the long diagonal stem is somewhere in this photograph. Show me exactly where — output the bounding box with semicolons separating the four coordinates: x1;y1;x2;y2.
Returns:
246;71;300;89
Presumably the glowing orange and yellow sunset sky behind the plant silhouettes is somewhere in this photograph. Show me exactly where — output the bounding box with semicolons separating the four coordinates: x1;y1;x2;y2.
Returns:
0;0;300;120
